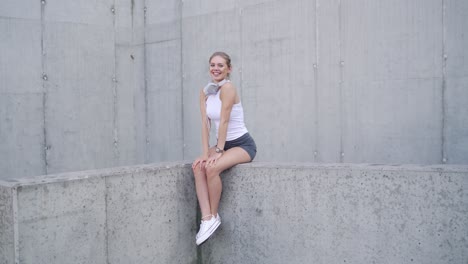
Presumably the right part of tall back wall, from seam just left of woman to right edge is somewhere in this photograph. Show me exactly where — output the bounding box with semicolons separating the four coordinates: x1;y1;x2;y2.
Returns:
182;0;468;164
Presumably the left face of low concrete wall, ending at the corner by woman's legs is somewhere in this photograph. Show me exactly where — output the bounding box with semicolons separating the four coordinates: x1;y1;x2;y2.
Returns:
0;164;197;264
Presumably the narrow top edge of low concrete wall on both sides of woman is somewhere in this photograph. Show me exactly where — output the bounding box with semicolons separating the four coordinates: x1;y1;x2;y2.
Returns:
0;161;468;188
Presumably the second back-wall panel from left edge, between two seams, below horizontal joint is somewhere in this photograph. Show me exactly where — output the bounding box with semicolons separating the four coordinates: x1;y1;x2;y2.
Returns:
44;23;116;173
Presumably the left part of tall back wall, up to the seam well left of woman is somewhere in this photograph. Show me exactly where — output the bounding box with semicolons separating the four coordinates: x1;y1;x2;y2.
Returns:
0;0;148;178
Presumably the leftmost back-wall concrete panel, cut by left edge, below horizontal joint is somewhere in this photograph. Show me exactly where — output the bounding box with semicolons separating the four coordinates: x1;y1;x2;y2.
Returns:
0;18;45;179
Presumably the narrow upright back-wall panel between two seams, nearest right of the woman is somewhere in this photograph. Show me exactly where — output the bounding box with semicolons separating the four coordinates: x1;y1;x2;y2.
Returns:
316;0;342;162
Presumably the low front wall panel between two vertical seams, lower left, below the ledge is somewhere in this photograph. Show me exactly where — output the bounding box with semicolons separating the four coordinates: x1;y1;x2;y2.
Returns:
18;178;107;264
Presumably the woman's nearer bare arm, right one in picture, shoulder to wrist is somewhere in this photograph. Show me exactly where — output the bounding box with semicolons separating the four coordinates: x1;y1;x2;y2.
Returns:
216;83;237;149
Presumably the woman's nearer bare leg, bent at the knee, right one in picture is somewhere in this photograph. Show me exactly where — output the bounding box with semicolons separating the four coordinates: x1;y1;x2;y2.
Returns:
206;147;251;216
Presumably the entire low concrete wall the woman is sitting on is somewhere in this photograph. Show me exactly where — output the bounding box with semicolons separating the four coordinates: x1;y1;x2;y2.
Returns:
0;162;468;264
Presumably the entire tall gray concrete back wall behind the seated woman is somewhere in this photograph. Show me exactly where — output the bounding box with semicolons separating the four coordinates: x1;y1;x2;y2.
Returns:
0;0;468;178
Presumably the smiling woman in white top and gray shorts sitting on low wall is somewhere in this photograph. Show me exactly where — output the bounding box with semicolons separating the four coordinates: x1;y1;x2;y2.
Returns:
192;52;257;245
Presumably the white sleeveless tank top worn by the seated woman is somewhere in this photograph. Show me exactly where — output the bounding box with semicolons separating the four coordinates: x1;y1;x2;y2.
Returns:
206;89;248;141
